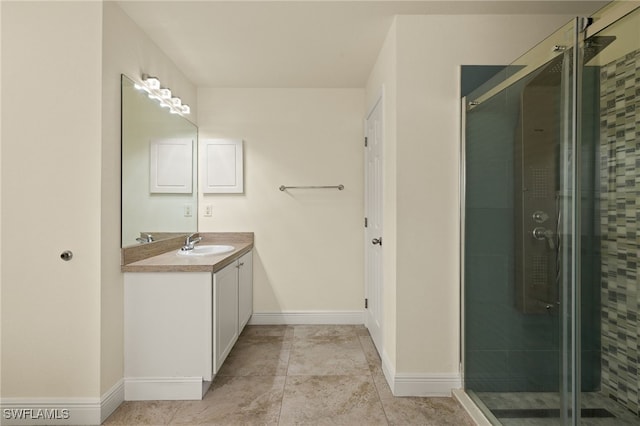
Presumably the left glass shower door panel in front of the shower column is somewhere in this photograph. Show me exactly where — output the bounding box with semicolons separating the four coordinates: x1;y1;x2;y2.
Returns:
463;19;580;424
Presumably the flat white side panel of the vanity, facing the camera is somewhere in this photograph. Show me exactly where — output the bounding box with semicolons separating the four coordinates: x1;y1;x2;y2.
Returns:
124;272;214;401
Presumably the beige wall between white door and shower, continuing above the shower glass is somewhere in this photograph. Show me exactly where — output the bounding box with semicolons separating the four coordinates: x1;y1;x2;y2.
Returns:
367;15;580;375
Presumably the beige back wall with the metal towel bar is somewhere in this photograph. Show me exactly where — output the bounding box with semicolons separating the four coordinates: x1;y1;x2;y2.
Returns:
198;89;365;312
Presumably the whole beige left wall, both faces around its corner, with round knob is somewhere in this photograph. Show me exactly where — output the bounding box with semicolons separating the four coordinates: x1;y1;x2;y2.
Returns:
0;2;197;398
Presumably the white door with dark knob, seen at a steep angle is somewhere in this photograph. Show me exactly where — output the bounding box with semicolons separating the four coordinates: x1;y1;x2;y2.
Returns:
364;97;383;354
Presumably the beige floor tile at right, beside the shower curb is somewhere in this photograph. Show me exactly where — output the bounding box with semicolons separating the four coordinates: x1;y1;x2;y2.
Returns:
374;376;475;426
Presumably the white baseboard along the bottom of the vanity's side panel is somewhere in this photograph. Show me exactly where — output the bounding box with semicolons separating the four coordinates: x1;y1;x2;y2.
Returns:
124;377;203;401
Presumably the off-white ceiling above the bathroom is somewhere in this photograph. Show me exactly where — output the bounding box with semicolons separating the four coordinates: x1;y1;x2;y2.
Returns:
117;0;603;88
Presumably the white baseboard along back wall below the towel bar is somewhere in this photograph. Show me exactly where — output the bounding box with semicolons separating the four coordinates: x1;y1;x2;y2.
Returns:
249;311;364;325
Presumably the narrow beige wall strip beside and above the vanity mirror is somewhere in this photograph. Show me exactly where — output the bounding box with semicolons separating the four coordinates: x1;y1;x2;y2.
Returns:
100;2;197;394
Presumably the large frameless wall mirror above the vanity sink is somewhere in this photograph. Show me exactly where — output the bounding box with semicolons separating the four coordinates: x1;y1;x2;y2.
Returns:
121;75;198;247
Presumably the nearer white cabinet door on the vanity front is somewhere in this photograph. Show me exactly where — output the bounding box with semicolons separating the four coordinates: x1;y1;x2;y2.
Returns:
213;262;239;373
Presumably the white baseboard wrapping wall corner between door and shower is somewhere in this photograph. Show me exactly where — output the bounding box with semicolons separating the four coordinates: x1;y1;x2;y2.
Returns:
381;351;462;396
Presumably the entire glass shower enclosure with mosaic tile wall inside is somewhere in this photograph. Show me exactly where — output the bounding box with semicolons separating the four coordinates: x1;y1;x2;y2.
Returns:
461;2;640;425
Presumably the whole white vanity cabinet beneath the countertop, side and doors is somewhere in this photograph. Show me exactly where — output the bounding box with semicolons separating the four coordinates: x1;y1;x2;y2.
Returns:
124;251;253;401
